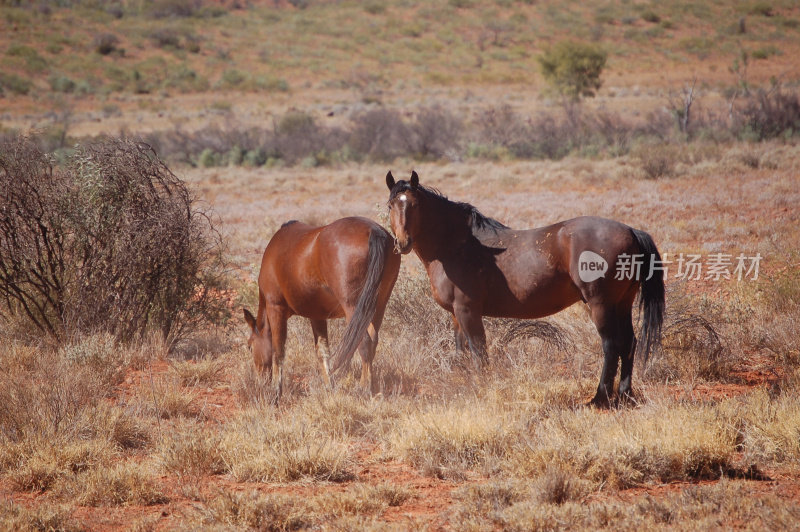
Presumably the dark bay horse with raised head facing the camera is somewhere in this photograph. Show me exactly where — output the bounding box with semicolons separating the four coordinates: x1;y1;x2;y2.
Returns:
386;172;664;406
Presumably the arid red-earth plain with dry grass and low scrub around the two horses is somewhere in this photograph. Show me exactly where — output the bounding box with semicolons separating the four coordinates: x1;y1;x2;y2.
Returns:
0;0;800;530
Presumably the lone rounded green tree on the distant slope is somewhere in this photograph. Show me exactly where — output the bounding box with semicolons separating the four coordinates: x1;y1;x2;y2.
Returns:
538;41;608;100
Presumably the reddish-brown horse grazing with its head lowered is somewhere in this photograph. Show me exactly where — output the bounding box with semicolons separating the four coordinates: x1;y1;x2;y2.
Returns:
239;217;400;401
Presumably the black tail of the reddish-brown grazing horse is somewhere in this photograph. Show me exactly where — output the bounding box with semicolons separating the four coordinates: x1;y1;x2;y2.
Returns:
332;228;391;373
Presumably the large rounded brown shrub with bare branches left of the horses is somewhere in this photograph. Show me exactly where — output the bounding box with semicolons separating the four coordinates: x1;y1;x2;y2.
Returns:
0;138;228;341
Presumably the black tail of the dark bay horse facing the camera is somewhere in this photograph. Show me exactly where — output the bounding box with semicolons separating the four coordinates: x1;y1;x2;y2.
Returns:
631;229;664;362
